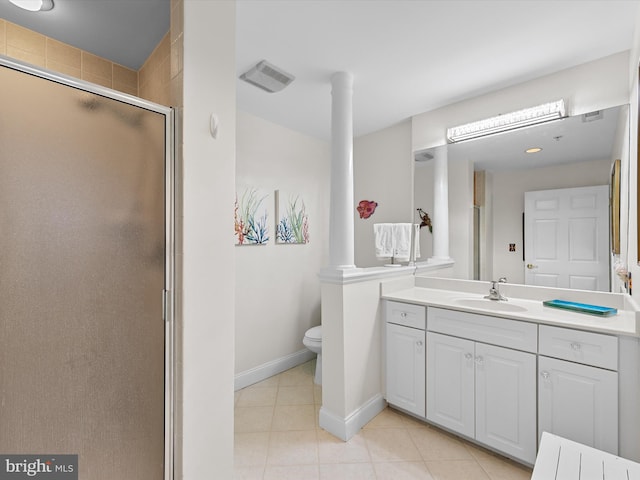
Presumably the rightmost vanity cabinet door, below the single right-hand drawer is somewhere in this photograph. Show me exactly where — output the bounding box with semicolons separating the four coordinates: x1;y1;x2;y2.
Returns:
538;356;618;455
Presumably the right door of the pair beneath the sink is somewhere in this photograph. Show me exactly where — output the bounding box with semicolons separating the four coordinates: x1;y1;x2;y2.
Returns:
475;343;537;464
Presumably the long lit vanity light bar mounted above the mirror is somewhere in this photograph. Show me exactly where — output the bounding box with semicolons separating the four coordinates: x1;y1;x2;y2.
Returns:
447;100;566;143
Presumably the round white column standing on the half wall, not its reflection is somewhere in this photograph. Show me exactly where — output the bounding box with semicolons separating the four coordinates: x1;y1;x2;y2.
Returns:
329;72;355;270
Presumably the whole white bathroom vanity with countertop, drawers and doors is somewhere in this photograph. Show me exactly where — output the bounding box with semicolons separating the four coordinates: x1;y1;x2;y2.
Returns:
382;279;640;465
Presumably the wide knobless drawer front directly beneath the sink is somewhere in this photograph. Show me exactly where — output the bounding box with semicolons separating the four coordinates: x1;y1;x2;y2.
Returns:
428;307;538;353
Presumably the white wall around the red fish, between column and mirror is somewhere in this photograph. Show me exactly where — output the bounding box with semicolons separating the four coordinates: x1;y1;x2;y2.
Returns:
353;120;418;267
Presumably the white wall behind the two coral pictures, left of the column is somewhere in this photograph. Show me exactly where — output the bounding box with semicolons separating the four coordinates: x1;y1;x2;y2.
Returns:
235;111;330;374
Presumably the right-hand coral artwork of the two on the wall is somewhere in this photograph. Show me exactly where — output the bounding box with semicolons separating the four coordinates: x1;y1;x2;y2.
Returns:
275;190;309;243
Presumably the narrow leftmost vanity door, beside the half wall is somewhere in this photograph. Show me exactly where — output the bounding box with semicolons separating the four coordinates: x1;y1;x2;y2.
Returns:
386;323;425;418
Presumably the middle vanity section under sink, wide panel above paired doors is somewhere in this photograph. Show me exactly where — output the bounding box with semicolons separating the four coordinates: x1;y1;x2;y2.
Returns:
427;307;537;463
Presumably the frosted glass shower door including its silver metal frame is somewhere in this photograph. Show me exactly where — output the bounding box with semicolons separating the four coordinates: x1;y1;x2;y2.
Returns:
0;57;174;480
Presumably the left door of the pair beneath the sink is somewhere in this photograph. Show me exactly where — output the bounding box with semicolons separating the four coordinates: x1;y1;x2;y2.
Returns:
427;332;475;437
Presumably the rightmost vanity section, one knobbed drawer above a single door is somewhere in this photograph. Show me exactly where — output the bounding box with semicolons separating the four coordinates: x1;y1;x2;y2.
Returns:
538;325;618;455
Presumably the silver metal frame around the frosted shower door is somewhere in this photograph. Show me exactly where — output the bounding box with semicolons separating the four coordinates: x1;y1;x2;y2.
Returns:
0;55;176;480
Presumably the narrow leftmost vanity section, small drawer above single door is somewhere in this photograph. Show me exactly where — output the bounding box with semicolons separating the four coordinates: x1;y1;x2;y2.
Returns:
385;301;426;418
